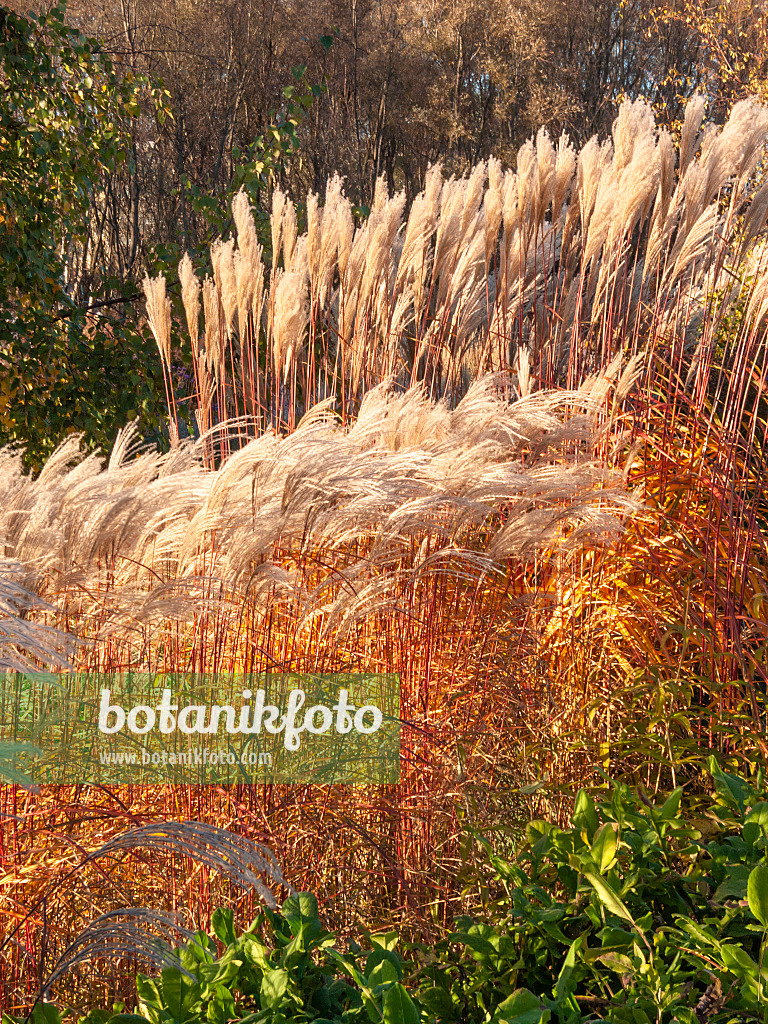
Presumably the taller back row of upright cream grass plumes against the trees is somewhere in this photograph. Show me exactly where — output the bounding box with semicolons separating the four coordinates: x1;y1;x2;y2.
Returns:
159;92;768;423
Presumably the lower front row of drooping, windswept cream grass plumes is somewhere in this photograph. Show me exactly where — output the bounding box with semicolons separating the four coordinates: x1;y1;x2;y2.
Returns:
2;356;651;655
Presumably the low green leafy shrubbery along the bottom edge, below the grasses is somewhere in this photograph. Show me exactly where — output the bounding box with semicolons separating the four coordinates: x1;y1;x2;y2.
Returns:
10;759;768;1024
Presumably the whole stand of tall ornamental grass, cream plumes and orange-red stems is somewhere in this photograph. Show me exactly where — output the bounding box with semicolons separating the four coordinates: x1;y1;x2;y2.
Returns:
0;98;768;1013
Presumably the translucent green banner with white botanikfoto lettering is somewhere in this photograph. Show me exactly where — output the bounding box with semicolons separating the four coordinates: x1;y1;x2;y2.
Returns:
0;673;400;785
